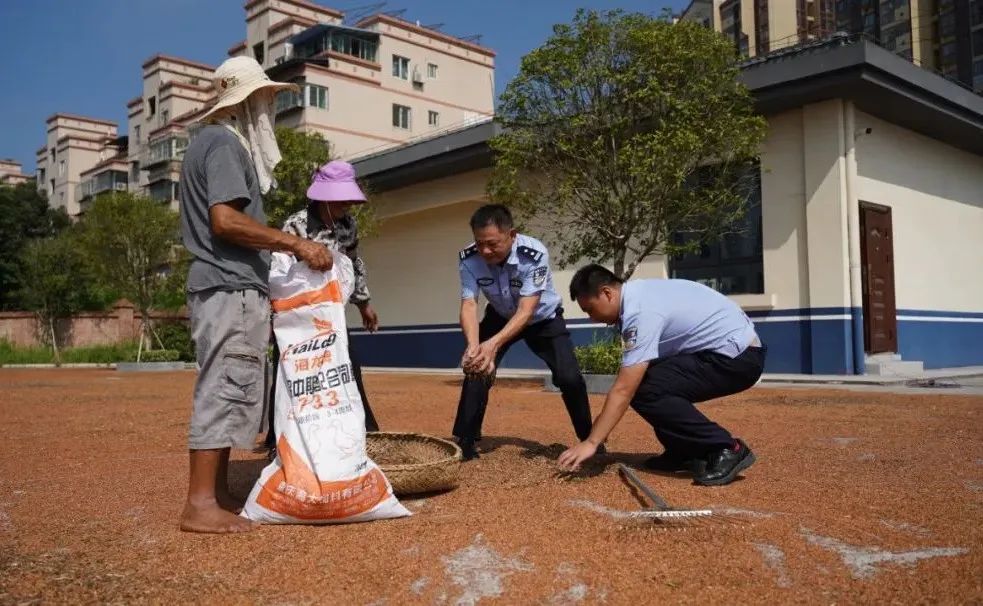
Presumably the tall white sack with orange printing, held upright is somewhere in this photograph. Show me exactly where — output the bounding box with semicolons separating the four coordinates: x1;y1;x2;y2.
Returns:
241;253;410;524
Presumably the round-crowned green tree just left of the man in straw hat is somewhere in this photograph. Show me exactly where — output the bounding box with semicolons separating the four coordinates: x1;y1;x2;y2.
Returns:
79;192;180;356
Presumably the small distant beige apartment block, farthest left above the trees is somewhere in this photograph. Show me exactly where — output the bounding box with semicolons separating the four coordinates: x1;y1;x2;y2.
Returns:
37;114;122;216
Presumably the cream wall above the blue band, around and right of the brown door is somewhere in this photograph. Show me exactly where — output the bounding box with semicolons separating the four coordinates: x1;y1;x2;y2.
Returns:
856;111;983;312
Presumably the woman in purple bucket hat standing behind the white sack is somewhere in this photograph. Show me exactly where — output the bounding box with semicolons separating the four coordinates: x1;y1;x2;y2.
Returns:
266;160;379;457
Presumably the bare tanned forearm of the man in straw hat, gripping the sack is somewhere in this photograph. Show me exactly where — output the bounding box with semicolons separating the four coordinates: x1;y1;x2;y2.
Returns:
208;200;333;271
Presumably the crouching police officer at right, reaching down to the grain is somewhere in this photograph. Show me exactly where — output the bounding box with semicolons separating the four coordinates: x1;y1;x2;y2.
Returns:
558;265;765;486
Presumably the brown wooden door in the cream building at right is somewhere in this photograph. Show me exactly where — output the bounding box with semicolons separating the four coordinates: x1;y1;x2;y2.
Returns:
860;202;898;354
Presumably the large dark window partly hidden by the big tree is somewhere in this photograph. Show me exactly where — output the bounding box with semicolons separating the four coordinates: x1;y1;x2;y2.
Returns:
669;165;765;295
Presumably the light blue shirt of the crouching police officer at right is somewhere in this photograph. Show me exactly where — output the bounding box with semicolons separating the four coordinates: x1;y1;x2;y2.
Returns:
619;280;756;366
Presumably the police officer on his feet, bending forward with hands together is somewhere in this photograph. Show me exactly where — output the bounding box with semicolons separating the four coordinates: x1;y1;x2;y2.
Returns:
454;204;591;460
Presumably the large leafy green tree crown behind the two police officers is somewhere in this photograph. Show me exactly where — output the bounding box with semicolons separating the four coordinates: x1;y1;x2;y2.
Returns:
489;10;765;278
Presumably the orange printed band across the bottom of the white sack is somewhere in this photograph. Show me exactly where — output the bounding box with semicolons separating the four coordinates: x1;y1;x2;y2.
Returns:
256;438;388;520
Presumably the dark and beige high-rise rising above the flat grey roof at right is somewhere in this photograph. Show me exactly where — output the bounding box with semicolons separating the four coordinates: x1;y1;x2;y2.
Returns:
679;0;983;92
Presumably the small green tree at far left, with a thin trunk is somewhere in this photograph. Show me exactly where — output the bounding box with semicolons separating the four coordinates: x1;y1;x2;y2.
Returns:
18;230;99;365
